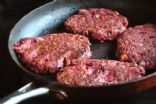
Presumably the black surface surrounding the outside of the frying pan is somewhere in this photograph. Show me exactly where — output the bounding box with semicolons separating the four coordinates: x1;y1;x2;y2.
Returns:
0;0;156;104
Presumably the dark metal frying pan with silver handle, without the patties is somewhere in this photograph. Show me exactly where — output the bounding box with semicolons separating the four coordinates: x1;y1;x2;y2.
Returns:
1;0;156;104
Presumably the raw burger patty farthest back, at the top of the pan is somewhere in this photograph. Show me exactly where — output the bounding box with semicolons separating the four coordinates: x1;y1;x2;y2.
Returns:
64;8;128;42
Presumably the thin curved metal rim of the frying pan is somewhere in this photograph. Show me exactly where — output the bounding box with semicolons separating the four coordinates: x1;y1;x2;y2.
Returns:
8;0;156;88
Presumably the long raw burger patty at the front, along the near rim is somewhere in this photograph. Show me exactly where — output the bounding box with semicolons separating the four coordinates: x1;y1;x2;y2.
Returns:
57;59;145;86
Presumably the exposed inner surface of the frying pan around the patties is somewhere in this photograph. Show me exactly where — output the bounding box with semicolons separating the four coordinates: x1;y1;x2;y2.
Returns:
9;0;156;83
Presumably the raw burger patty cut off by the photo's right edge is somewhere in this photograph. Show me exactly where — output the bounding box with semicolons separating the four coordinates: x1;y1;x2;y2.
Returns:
117;24;156;69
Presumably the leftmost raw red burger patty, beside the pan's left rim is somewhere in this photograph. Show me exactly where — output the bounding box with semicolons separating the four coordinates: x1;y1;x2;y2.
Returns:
14;33;91;73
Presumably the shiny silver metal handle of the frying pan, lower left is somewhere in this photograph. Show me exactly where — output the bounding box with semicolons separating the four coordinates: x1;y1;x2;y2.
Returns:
0;82;67;104
